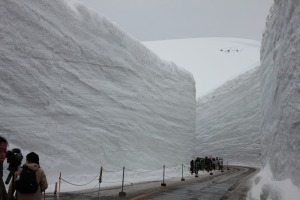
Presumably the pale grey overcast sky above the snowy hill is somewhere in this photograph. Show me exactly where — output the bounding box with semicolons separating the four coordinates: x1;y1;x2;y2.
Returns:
78;0;273;41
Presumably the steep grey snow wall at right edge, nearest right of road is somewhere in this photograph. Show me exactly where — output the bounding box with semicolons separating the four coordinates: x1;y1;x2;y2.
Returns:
260;0;300;186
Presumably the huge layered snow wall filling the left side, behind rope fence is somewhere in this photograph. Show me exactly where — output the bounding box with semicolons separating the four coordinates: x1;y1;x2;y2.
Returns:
0;0;196;180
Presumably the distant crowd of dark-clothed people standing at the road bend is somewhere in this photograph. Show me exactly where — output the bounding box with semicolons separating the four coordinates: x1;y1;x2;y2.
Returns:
190;157;223;175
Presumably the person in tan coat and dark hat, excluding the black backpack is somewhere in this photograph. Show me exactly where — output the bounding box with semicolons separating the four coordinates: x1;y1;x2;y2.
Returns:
8;152;48;200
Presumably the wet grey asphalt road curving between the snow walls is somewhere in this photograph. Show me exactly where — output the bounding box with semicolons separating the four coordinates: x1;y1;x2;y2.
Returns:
46;166;258;200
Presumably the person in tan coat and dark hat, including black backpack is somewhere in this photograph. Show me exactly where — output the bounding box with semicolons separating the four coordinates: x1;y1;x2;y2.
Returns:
8;152;48;200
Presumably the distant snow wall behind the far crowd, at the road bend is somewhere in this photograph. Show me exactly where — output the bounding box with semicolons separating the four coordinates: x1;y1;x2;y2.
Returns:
194;67;261;166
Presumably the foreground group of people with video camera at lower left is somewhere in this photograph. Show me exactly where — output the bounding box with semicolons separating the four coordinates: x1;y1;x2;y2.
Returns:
0;136;48;200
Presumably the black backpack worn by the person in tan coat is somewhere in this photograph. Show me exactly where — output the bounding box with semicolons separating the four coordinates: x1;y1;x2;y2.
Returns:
15;165;38;193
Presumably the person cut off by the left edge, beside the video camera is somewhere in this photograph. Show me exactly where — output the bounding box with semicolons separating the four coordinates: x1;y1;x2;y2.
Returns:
0;136;8;200
